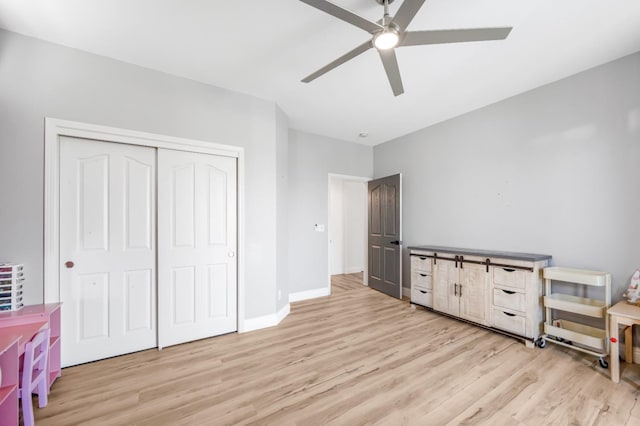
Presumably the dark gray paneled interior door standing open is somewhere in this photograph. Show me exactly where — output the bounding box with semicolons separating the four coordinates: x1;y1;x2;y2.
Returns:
368;174;402;299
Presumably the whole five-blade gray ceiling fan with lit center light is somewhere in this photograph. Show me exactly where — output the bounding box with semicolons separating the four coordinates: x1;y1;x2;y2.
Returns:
300;0;512;96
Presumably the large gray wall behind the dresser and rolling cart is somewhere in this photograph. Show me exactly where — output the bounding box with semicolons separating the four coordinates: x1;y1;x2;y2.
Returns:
374;53;640;300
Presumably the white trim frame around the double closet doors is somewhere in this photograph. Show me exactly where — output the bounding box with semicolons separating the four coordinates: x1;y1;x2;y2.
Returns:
44;117;245;333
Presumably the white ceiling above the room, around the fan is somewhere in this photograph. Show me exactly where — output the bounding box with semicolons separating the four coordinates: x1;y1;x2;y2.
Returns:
0;0;640;145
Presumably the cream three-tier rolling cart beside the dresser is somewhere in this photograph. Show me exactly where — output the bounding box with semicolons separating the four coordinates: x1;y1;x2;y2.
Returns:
539;266;611;368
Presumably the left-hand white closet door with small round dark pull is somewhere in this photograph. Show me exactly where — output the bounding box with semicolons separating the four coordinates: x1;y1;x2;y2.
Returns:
60;137;156;366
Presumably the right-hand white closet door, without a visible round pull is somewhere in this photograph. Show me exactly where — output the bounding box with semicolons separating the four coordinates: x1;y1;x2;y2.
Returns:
158;149;237;348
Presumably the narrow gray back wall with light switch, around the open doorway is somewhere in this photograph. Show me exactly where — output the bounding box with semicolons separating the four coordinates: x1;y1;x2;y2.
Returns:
289;130;373;293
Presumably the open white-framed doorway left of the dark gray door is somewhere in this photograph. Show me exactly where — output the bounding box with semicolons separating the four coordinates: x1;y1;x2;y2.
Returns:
327;174;370;293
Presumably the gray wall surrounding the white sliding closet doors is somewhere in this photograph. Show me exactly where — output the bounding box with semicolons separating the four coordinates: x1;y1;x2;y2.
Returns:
0;31;286;318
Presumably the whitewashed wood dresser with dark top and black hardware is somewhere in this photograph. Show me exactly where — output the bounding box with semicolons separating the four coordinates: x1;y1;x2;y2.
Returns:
409;246;551;347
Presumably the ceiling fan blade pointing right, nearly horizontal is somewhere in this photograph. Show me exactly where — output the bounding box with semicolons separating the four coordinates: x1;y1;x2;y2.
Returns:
400;27;512;46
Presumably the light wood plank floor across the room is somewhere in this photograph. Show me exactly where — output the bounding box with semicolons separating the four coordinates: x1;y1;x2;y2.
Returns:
34;275;640;425
